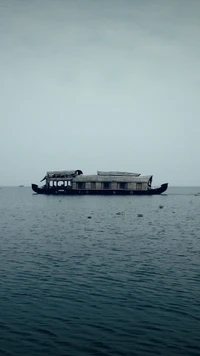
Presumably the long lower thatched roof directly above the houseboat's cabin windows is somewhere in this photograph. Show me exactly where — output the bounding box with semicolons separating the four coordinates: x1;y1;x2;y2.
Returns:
73;175;153;183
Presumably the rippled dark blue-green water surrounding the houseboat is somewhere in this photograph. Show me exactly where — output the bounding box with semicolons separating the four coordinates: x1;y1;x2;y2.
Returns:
0;188;200;356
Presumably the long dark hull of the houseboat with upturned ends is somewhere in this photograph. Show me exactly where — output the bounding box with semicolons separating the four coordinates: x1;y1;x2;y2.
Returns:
32;183;168;195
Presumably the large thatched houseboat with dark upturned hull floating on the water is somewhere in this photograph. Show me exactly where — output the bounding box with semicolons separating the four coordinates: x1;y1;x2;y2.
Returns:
32;169;168;195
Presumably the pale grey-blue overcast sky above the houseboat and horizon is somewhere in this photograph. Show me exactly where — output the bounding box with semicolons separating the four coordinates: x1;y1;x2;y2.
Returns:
0;0;200;186
